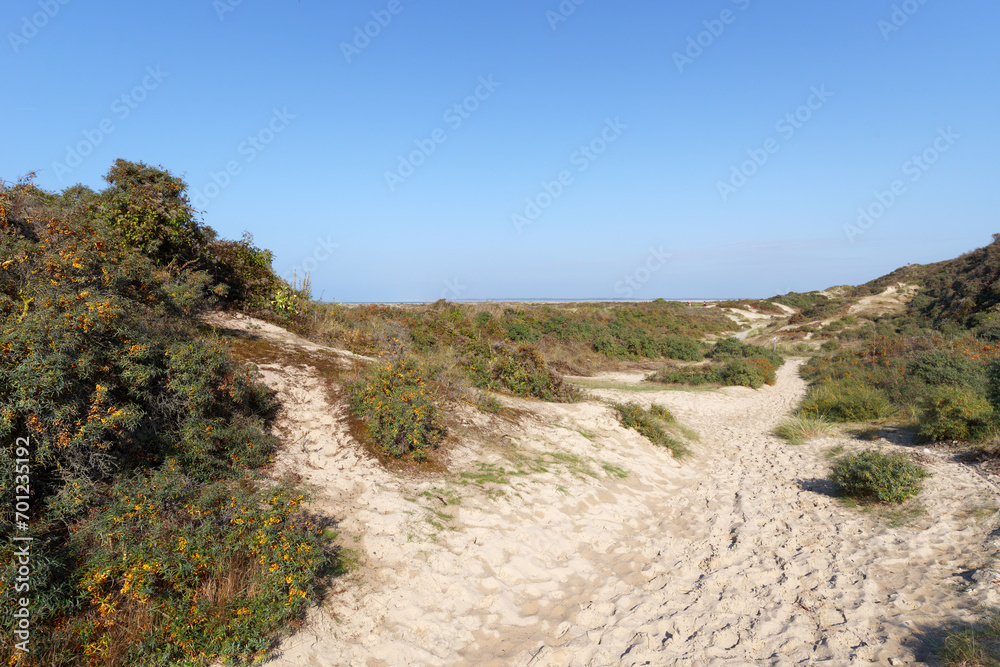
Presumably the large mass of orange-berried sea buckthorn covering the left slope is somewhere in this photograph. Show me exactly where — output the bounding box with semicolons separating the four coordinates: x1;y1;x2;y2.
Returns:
0;167;334;667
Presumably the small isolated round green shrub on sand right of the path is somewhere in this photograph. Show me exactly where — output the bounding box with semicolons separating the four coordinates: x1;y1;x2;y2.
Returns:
830;450;930;503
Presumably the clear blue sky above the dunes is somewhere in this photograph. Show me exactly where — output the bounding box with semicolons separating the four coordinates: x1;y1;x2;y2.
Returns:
0;0;1000;301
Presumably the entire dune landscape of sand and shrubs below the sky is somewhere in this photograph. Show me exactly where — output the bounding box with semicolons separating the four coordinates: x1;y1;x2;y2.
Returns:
0;161;1000;666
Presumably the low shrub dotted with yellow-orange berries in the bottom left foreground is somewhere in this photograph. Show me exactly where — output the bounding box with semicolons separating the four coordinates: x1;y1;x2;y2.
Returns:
49;472;333;665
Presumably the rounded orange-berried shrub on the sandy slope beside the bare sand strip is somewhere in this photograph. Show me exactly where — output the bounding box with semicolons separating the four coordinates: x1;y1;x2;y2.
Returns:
345;357;445;459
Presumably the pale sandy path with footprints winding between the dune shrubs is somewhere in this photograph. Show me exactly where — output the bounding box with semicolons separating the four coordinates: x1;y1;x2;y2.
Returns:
205;316;1000;667
